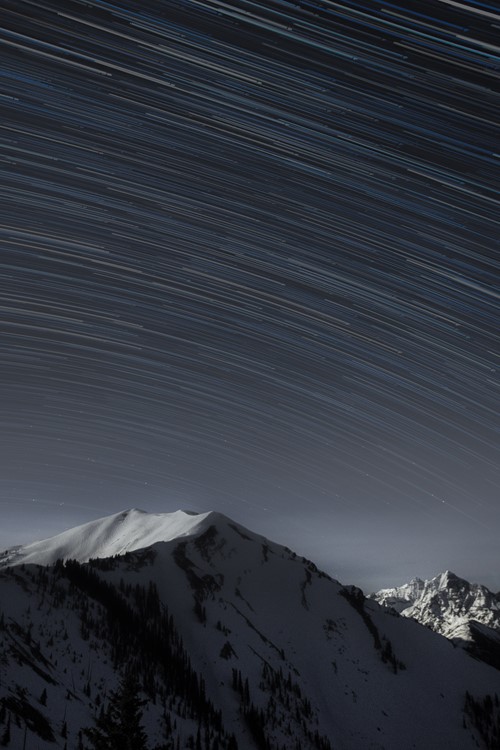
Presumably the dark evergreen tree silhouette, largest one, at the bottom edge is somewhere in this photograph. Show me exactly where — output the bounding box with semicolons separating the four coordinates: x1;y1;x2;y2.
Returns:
85;674;147;750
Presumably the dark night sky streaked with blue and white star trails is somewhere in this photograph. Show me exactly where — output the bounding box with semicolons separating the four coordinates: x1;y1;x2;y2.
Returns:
0;0;500;590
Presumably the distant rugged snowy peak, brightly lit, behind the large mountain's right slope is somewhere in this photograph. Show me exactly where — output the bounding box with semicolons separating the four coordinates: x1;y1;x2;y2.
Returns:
372;570;500;639
